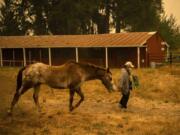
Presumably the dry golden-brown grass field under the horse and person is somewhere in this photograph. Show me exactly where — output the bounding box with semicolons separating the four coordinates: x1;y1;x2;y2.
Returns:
0;67;180;135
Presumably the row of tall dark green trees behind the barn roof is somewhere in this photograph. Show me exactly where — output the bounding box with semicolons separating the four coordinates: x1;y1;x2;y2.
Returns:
0;0;180;48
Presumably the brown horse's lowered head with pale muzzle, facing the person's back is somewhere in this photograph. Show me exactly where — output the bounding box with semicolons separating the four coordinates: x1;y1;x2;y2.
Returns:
98;68;115;92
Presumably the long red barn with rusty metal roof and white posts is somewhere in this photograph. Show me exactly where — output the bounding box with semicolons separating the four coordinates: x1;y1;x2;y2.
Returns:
0;32;167;67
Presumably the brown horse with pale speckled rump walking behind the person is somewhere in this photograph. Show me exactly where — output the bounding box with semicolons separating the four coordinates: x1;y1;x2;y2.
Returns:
8;61;114;114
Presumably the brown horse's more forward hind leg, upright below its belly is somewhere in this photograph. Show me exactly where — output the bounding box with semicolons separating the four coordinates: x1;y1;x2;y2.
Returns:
33;84;41;112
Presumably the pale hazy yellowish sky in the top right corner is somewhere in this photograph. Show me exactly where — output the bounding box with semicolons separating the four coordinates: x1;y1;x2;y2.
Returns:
164;0;180;25
